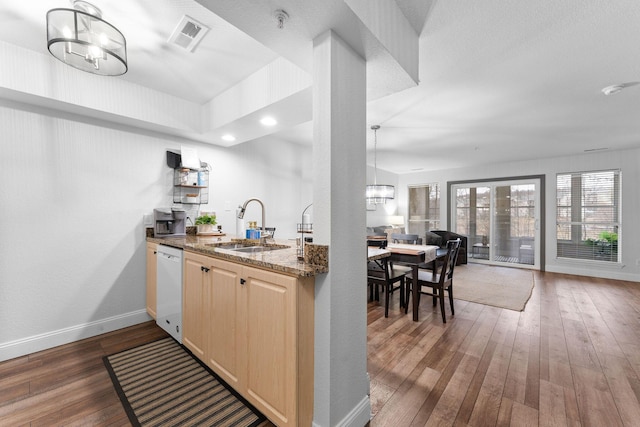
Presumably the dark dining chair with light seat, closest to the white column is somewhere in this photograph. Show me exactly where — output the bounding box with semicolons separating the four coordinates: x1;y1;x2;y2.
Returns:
367;258;411;317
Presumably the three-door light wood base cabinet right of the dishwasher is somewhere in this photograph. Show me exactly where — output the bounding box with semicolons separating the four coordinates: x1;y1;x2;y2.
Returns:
183;252;314;426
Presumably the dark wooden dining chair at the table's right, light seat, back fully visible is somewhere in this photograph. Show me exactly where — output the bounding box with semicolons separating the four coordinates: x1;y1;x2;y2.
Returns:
404;239;461;323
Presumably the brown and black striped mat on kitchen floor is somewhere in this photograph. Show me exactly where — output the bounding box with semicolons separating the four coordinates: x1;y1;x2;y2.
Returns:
104;338;266;427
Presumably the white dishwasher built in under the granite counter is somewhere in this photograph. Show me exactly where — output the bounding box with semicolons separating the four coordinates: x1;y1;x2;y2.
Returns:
156;245;183;344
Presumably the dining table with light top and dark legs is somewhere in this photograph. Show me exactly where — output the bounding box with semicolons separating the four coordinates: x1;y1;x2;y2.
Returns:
367;243;440;322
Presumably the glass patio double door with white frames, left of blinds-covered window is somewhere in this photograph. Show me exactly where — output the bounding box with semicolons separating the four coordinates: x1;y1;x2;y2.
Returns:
450;178;541;269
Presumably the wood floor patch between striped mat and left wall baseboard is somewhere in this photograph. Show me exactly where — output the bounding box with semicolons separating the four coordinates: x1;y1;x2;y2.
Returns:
0;322;167;427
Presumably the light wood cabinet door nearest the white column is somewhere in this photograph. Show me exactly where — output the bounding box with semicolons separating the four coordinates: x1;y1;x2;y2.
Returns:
243;267;298;426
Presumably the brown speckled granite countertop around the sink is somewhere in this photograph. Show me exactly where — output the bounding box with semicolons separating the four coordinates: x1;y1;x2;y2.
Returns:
147;234;329;277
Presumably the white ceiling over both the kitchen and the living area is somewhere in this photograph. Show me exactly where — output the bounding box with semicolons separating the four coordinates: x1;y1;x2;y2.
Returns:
0;0;640;174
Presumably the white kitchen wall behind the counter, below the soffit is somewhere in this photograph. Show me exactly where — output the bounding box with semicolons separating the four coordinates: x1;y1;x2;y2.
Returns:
0;100;312;360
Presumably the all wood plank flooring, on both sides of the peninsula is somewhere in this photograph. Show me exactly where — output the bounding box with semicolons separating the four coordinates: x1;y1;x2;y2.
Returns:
0;273;640;427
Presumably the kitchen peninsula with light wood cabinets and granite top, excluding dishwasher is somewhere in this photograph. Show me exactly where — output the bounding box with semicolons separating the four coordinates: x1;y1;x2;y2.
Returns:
147;235;328;426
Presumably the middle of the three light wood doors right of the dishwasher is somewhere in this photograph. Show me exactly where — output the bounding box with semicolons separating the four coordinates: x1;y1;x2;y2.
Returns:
206;259;246;392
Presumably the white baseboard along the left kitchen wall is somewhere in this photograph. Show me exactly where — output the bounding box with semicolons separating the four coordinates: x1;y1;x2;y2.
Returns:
0;309;151;362
